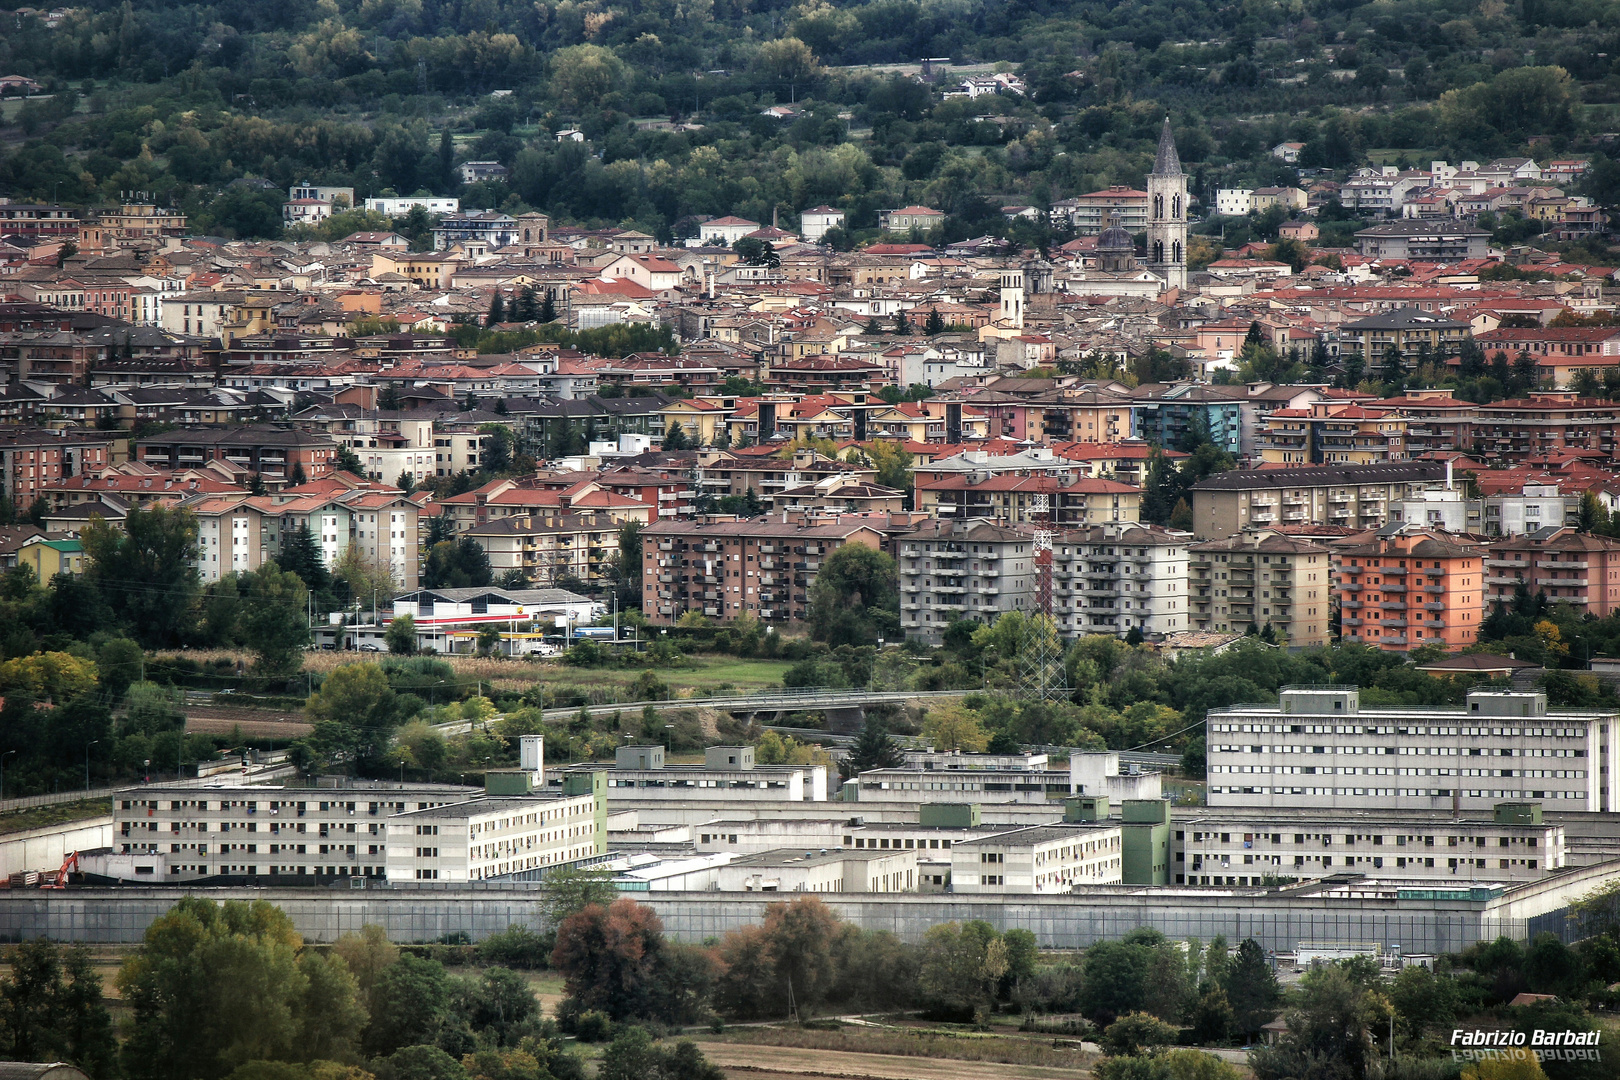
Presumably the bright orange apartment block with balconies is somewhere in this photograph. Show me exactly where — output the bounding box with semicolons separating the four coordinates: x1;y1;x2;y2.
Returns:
1332;526;1487;653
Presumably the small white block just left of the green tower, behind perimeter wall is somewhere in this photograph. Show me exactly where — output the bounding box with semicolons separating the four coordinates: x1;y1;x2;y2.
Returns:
951;823;1124;895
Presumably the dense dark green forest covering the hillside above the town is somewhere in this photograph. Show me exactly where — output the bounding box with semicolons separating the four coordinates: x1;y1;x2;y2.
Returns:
0;0;1620;241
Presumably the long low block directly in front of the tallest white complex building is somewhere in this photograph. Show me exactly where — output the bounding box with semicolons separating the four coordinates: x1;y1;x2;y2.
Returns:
1175;803;1565;887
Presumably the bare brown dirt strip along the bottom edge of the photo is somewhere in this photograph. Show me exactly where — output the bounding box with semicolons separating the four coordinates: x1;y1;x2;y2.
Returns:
686;1041;1090;1080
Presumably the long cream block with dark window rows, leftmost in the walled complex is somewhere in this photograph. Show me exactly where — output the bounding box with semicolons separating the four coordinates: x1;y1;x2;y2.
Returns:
112;780;481;884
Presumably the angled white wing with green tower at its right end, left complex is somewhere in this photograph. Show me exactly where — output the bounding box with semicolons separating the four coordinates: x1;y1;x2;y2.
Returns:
386;769;608;882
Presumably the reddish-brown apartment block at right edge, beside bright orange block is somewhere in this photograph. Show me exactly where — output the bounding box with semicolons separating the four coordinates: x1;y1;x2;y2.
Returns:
1486;526;1620;619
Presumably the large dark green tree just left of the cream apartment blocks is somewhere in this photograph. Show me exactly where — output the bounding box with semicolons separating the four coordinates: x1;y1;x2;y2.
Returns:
81;505;198;648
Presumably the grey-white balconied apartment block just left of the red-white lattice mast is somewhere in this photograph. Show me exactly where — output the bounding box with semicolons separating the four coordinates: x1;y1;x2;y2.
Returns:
893;518;1030;644
